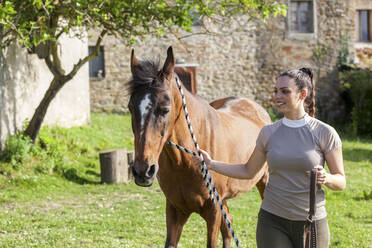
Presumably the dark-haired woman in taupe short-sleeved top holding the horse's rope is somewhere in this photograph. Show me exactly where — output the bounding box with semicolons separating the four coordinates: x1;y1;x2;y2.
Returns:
195;68;346;248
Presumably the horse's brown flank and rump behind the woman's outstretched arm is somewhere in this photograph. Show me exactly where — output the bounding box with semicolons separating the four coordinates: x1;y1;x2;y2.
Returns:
210;97;271;199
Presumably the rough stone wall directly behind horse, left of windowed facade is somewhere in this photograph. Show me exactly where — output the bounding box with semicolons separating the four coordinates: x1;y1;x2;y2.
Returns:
91;17;259;113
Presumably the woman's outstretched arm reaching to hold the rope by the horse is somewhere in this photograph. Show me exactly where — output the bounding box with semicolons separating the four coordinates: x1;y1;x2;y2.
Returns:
195;148;266;179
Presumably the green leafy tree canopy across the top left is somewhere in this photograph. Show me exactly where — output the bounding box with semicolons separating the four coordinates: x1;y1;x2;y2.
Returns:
0;0;286;47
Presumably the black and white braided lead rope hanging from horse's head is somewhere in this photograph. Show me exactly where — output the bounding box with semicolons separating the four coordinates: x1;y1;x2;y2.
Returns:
167;76;241;248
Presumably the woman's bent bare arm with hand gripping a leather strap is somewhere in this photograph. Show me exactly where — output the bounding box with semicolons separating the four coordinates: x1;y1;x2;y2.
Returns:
317;147;346;190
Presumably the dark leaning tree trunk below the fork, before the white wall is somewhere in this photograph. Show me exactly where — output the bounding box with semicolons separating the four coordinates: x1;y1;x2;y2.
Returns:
25;76;69;143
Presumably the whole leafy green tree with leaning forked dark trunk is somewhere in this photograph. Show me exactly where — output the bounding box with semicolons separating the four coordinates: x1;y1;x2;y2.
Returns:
0;0;286;142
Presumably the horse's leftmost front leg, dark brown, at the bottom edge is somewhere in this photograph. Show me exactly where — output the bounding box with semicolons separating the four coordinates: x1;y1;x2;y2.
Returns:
165;200;190;248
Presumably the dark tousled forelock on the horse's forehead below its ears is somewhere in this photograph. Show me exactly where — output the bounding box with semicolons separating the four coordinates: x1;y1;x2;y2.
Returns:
127;60;162;95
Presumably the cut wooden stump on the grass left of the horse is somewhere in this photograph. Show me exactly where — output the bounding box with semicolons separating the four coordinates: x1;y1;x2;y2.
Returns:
99;148;133;184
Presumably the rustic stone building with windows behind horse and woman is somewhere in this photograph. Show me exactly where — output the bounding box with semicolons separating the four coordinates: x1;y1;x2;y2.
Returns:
89;0;372;121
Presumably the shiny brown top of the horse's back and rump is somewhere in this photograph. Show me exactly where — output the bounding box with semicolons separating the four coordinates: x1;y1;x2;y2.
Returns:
210;97;271;127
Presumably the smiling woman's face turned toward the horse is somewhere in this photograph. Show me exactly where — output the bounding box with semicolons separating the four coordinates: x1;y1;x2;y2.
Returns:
274;76;306;114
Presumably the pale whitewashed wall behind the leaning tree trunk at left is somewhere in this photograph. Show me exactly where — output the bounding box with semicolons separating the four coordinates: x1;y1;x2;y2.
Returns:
0;33;90;148
